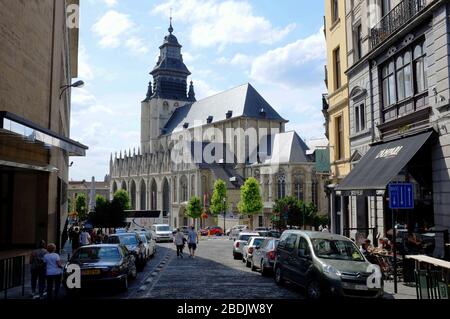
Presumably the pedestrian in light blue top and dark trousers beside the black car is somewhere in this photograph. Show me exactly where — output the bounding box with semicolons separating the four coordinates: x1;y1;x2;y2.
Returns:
44;244;63;300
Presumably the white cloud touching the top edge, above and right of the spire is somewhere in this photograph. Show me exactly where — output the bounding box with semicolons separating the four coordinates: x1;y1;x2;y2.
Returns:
152;0;295;48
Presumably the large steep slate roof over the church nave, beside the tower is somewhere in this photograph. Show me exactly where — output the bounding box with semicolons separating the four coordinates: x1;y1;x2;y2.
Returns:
163;83;287;134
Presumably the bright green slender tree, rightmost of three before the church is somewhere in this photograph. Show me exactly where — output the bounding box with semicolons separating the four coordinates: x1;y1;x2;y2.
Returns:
238;177;263;228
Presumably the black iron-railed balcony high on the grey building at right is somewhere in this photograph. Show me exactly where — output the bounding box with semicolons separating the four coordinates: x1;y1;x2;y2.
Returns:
370;0;427;49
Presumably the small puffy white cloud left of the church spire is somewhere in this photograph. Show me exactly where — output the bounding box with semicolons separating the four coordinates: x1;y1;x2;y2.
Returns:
92;10;136;48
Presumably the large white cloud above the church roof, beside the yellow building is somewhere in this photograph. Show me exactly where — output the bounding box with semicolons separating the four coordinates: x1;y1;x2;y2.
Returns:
250;29;326;86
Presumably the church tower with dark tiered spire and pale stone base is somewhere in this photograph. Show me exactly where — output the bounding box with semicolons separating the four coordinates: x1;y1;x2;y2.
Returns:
141;18;195;154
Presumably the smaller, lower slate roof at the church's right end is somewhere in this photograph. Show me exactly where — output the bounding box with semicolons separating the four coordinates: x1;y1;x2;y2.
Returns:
266;131;310;164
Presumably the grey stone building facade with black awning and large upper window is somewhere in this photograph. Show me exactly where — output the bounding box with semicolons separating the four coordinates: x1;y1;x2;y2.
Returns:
337;0;450;255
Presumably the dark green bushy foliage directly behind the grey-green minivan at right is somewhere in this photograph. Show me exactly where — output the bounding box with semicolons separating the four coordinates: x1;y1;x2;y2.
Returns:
272;196;317;228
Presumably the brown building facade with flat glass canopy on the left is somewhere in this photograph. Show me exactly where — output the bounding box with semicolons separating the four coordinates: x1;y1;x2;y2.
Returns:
0;0;87;254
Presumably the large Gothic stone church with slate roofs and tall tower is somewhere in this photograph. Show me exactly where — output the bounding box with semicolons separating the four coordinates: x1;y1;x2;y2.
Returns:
109;23;328;228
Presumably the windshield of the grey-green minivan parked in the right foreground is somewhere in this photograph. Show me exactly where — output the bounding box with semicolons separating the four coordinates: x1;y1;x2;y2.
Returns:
312;238;365;261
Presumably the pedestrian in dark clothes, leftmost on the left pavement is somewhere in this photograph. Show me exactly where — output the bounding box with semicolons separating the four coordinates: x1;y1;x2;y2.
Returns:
30;240;48;299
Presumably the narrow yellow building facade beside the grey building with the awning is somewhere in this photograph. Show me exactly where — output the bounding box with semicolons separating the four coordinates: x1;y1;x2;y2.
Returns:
324;0;350;232
